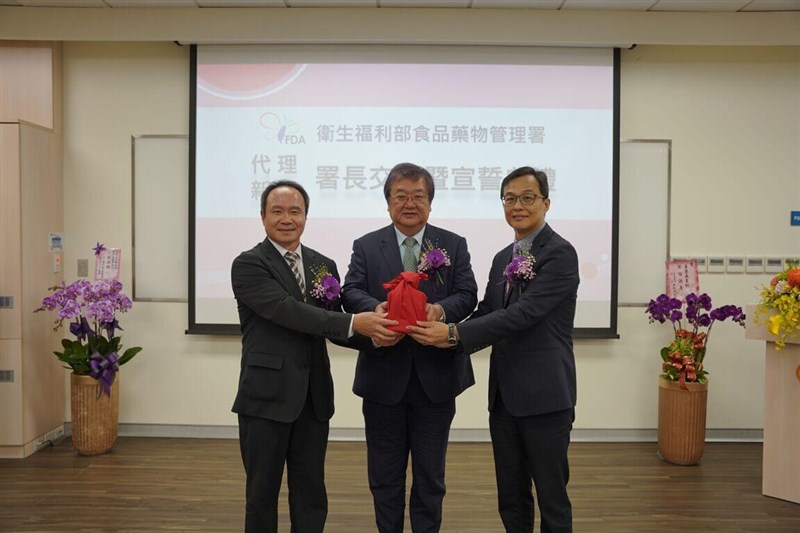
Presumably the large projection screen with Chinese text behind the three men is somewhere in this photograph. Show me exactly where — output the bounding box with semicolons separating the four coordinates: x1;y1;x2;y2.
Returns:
188;45;619;337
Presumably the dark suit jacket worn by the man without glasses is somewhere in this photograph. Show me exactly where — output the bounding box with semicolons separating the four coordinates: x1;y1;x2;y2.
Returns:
231;239;351;422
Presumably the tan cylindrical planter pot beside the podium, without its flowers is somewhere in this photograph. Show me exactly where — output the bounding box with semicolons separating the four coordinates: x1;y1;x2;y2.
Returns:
658;379;708;465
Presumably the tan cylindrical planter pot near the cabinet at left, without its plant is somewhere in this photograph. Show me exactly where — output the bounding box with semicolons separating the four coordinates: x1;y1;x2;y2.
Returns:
70;373;119;455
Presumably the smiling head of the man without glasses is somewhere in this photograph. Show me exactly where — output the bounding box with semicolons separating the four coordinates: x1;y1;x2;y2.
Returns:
261;187;306;251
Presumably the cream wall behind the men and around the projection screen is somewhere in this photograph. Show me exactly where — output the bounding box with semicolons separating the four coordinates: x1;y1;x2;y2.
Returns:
42;10;800;429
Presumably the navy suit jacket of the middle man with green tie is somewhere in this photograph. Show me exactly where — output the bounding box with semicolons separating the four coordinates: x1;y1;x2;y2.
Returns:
342;224;478;405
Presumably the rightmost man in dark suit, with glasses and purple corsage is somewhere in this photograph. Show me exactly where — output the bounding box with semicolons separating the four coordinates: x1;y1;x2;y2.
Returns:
409;167;579;533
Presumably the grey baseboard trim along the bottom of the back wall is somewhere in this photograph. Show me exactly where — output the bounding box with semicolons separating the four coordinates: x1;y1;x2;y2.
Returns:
64;422;764;442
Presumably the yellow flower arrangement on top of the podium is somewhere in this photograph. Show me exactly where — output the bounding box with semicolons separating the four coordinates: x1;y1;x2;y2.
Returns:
755;263;800;350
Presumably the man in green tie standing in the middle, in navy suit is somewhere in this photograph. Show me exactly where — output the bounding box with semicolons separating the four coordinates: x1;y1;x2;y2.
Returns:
342;163;477;533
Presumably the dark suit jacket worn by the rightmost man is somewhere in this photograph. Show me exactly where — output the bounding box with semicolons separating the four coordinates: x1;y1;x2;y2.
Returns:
458;224;579;416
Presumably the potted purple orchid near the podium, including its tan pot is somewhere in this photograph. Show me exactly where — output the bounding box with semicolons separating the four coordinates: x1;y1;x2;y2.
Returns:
645;293;745;465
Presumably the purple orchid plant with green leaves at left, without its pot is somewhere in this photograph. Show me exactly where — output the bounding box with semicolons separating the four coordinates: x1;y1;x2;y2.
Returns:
34;262;142;396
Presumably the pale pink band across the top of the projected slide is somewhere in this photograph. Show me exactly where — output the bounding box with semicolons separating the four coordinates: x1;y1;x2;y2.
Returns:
197;64;613;109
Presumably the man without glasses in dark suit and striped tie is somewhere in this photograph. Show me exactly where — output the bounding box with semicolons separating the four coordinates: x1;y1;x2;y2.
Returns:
231;181;397;533
